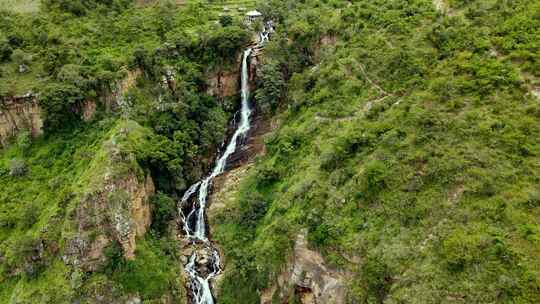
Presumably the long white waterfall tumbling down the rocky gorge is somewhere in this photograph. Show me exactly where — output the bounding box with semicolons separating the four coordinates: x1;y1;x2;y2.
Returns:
178;48;251;304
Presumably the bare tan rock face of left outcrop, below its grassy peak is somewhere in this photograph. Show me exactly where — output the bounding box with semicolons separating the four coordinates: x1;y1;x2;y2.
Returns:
63;174;155;271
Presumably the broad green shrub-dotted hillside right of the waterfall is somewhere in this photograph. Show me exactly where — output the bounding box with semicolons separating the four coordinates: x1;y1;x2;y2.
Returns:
214;1;540;303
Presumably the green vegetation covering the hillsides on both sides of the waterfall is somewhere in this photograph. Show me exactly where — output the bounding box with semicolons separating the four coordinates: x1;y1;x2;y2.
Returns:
0;0;540;304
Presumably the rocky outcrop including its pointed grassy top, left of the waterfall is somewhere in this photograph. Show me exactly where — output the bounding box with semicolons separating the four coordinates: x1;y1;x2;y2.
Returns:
63;121;155;271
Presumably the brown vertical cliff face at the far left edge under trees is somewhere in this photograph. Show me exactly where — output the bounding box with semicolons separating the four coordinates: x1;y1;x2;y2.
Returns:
0;94;43;146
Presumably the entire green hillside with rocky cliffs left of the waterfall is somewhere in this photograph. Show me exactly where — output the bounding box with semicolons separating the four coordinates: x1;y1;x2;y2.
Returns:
0;0;250;303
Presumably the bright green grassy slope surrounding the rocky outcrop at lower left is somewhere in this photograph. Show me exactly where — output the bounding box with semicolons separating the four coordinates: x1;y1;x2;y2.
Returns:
0;120;188;303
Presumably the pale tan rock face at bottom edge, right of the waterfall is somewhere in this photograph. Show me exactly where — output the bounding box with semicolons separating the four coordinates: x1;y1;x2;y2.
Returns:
261;231;347;304
